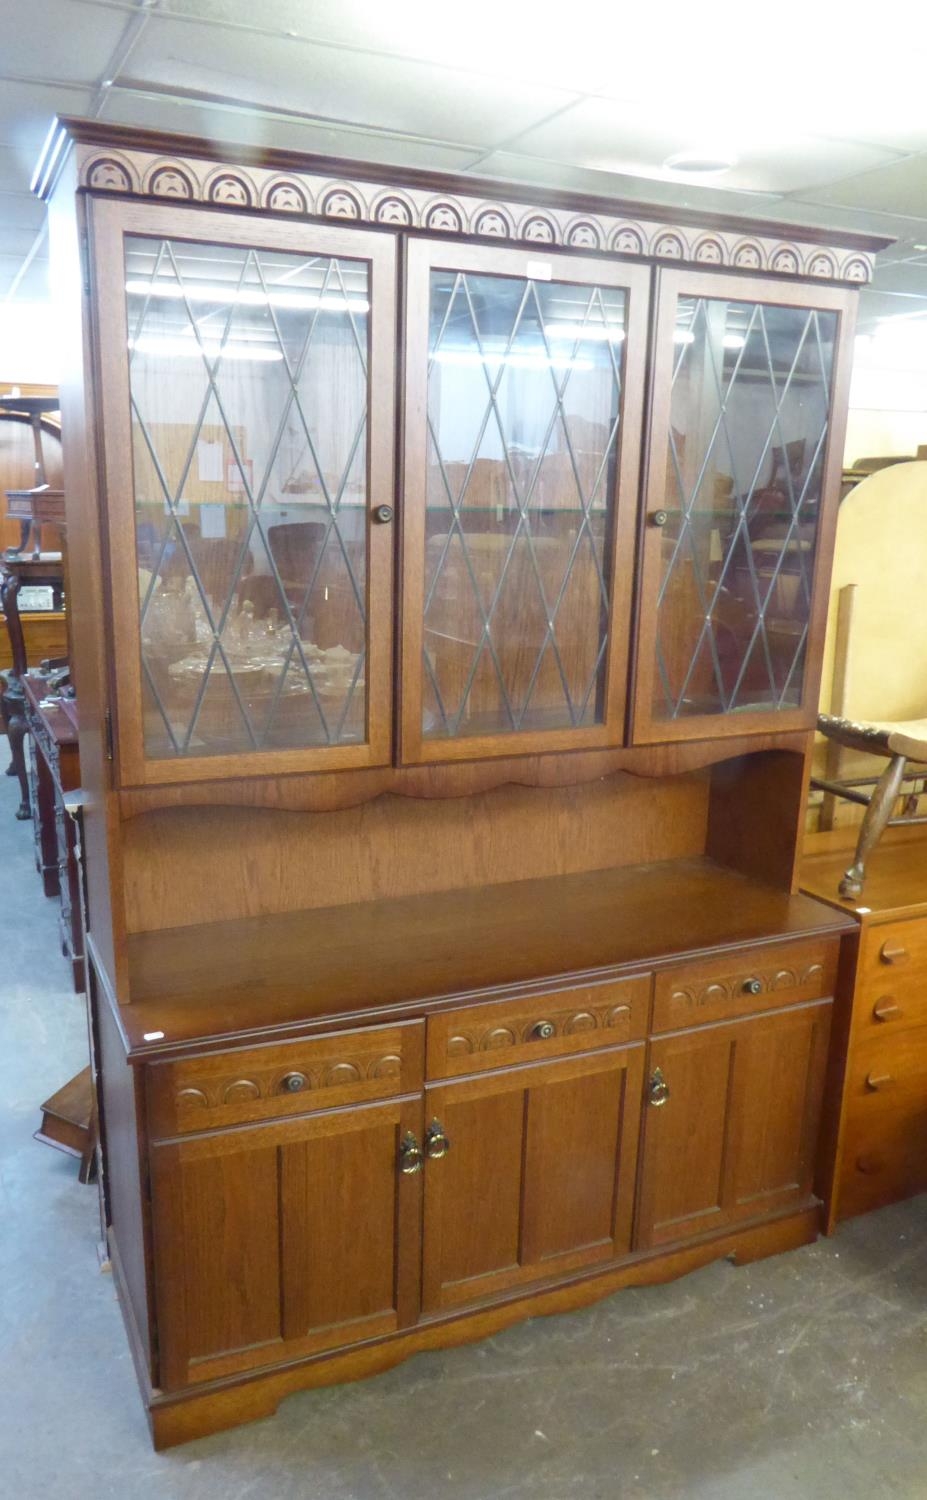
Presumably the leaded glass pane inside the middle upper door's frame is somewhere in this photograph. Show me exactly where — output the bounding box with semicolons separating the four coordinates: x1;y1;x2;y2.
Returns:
423;270;626;738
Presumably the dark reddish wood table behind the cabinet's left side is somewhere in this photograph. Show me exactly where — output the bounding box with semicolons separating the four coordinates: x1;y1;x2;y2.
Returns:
23;672;84;992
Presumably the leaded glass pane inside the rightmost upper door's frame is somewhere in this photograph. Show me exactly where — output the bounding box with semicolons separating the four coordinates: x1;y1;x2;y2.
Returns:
654;297;837;719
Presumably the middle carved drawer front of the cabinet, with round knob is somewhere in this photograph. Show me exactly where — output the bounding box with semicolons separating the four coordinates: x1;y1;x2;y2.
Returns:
428;975;651;1079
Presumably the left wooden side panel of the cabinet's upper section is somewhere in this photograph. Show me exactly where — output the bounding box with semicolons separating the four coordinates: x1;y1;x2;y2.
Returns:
48;165;128;999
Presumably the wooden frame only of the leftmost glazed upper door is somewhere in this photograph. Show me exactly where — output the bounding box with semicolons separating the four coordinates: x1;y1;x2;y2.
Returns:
89;197;396;786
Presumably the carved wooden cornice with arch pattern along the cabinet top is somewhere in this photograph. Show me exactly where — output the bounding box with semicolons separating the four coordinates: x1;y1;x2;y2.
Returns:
36;120;888;285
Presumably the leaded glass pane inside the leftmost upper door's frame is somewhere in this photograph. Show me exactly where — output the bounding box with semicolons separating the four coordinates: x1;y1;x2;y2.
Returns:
126;236;369;758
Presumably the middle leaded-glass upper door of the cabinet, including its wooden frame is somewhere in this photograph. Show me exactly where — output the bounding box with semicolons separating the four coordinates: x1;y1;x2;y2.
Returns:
402;240;650;762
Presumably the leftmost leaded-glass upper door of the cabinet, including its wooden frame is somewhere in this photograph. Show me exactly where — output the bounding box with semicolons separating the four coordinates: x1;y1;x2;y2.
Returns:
92;201;395;785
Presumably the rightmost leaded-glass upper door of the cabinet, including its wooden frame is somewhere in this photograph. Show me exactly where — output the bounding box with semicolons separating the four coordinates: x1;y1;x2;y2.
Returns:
633;272;855;744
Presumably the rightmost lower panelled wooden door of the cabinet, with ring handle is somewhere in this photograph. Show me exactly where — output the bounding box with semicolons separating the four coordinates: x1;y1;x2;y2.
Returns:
636;1001;831;1250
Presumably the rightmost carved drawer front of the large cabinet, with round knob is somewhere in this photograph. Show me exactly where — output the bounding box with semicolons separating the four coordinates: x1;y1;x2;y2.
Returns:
653;939;840;1032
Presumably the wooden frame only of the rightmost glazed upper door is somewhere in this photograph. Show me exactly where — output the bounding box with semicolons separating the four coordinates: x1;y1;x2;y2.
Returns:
629;269;858;746
